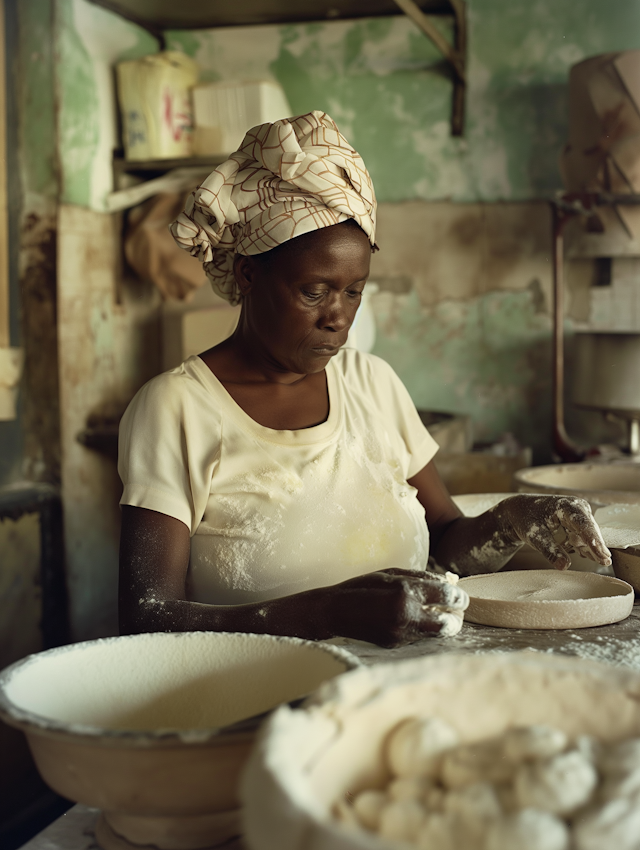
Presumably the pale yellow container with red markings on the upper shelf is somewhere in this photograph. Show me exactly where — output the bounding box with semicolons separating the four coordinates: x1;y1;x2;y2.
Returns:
117;50;198;161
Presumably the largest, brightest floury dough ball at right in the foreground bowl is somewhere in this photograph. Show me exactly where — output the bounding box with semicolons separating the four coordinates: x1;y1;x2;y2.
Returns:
515;750;598;815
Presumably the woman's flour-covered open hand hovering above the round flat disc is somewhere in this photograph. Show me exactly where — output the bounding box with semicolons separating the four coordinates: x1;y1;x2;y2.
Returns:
493;494;611;570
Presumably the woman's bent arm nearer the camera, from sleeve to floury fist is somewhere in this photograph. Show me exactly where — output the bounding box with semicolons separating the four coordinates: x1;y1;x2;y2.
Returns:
119;505;468;646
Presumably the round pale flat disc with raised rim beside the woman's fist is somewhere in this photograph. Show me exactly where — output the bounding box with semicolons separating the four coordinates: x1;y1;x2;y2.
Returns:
459;570;634;629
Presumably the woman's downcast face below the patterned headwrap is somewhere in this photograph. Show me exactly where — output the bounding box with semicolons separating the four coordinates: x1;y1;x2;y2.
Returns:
234;221;371;375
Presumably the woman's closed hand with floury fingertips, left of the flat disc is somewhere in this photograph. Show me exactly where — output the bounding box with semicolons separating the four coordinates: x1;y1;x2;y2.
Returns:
318;570;469;647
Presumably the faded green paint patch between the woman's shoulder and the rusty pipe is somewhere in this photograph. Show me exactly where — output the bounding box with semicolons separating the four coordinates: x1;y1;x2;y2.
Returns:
375;289;551;451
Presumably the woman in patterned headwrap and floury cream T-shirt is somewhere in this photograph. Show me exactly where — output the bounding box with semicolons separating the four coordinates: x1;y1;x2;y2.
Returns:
119;112;610;646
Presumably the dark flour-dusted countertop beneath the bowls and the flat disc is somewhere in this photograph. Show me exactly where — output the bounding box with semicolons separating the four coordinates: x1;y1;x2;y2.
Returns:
22;605;640;850
